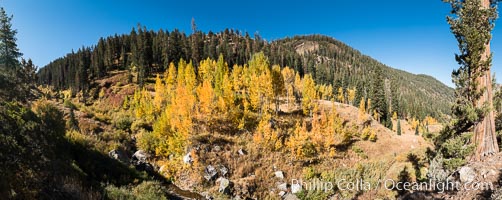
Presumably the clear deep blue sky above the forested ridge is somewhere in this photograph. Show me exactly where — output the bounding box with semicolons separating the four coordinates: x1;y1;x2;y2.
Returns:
0;0;502;86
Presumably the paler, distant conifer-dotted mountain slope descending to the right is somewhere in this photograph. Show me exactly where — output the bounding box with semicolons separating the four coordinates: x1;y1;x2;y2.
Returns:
274;35;453;118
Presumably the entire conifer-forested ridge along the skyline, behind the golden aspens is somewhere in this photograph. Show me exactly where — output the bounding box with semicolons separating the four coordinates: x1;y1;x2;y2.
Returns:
38;27;453;119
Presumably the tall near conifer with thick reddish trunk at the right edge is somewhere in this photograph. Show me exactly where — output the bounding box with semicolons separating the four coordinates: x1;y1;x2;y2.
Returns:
444;0;499;160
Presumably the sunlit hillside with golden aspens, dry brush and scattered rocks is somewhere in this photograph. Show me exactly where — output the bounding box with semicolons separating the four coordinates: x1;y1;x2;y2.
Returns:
29;50;440;199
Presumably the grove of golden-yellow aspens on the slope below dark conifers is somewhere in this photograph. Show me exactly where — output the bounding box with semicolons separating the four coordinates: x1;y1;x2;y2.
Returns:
124;53;355;163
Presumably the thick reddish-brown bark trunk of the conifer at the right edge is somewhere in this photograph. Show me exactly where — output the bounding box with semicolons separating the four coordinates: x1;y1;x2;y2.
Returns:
474;0;499;160
